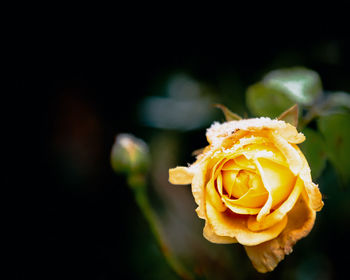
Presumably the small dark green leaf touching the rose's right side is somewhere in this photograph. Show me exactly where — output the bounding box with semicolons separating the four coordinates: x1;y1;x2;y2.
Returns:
300;128;327;179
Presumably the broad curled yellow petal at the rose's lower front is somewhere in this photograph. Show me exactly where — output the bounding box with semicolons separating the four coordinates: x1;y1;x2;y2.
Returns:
206;202;288;246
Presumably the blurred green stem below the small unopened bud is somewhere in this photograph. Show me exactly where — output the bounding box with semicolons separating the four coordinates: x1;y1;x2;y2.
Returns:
132;179;195;279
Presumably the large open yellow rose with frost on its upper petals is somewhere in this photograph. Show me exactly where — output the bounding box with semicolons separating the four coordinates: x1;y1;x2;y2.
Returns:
169;118;323;272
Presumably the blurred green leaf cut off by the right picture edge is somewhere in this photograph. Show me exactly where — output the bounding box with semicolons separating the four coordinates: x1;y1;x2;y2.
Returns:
318;113;350;184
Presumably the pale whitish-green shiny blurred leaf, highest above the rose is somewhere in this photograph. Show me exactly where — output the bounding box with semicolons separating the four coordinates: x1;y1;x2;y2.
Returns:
262;67;322;105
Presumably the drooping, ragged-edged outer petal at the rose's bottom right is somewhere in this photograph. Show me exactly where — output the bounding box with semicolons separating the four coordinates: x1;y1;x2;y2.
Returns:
245;193;316;273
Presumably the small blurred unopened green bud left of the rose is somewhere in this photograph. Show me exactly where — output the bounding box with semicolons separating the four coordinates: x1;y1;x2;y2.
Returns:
111;133;150;174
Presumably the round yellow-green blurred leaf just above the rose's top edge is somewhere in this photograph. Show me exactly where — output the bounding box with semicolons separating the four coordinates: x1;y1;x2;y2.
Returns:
246;83;295;118
